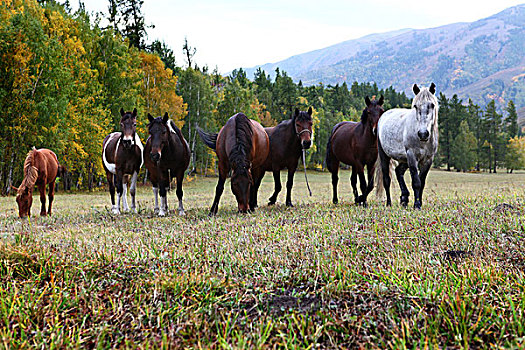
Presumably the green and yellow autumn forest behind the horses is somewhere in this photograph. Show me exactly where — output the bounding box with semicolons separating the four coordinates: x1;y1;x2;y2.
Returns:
0;0;525;194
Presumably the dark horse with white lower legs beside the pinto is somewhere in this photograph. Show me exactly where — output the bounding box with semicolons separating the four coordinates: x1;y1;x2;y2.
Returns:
144;113;190;216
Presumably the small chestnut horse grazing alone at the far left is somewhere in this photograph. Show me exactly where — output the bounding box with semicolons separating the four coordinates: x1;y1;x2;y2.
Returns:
13;147;61;218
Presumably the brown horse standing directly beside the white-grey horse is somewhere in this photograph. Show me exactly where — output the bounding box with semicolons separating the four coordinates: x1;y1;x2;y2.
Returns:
326;96;384;207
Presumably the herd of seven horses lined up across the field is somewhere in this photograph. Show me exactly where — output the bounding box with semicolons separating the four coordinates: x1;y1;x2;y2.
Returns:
15;83;438;218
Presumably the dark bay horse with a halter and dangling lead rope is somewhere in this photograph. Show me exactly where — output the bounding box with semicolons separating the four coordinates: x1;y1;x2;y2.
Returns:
252;107;313;207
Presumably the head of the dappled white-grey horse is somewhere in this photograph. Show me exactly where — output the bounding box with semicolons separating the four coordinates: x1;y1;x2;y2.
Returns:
412;83;438;142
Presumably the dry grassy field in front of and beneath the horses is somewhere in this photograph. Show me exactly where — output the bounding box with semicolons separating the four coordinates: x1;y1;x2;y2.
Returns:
0;171;525;349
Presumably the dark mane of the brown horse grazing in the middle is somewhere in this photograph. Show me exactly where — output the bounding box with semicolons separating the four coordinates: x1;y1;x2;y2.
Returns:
230;113;253;175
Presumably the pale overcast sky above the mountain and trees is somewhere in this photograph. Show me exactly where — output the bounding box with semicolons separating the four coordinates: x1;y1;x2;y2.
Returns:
70;0;524;73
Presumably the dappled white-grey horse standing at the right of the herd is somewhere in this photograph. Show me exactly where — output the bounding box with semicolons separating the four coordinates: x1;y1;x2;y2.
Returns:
376;83;439;209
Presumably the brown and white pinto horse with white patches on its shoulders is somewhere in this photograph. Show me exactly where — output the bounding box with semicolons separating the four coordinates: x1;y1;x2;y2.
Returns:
102;108;144;214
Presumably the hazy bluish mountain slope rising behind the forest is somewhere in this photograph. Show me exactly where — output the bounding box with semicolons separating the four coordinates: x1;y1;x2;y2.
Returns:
247;4;525;113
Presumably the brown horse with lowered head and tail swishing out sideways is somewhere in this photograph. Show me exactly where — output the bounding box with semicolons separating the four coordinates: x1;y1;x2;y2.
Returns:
197;113;270;216
